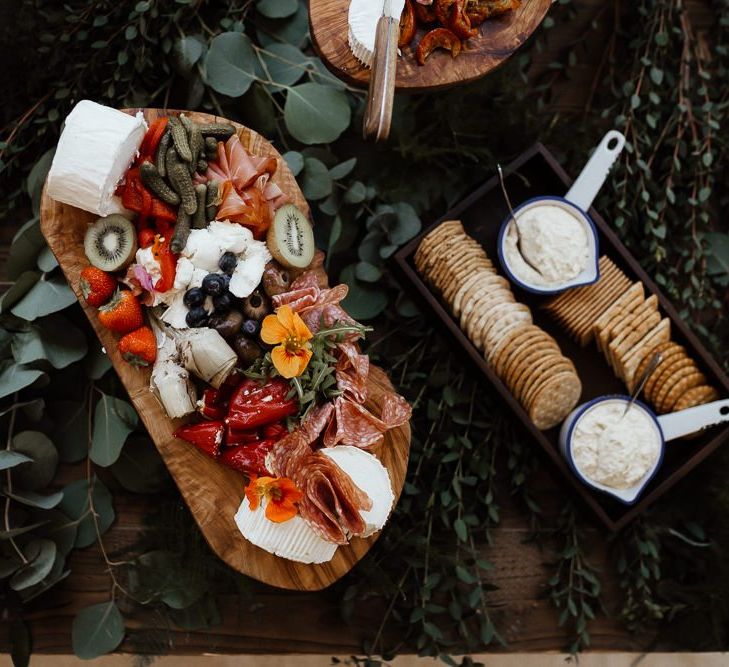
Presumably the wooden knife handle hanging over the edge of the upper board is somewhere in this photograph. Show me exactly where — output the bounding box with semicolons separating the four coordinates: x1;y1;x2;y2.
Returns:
362;16;400;142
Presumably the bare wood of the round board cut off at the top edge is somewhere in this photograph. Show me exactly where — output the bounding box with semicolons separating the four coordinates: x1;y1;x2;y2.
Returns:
309;0;552;93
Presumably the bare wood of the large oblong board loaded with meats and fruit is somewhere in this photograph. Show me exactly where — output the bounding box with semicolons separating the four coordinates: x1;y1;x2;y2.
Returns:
41;109;410;591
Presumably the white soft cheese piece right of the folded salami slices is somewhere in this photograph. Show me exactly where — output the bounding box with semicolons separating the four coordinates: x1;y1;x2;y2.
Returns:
320;445;395;537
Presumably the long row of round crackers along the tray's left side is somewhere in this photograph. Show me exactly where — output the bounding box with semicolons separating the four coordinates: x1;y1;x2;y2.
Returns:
415;220;582;430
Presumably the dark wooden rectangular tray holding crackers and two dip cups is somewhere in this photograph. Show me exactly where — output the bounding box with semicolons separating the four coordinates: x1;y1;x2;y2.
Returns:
395;144;729;531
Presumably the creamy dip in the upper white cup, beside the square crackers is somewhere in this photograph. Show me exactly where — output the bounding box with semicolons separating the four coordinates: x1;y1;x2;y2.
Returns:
504;204;590;287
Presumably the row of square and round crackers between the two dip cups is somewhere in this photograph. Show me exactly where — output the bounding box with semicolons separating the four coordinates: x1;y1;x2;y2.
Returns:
545;257;719;414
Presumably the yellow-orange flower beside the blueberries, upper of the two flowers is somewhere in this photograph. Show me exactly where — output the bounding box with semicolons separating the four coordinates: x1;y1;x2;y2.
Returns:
261;306;312;378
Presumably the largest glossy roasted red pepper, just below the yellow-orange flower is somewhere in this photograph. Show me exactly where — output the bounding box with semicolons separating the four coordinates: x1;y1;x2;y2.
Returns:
225;378;298;430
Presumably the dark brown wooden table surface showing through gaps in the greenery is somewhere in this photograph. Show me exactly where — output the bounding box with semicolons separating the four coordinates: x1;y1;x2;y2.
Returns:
0;0;712;655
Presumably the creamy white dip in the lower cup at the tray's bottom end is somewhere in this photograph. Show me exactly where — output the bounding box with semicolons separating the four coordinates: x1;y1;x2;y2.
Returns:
572;401;661;489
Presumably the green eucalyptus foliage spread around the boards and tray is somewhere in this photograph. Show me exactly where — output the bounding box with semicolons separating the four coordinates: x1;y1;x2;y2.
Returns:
0;0;729;664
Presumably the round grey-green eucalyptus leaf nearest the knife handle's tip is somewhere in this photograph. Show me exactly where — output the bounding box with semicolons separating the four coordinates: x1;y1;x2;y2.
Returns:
284;82;351;144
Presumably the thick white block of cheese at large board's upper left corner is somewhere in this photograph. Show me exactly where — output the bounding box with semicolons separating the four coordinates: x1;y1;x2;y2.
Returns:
48;100;147;216
